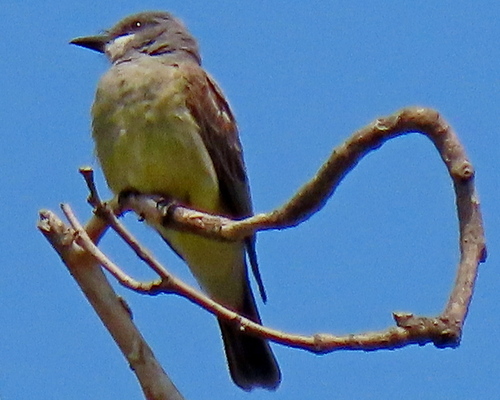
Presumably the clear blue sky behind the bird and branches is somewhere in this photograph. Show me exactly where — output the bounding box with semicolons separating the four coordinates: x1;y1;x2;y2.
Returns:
0;0;500;400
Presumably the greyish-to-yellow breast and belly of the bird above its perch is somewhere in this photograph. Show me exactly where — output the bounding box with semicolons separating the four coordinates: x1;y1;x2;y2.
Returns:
93;63;219;211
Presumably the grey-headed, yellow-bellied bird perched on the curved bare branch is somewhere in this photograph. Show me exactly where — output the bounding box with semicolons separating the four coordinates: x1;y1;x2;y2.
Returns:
70;11;281;391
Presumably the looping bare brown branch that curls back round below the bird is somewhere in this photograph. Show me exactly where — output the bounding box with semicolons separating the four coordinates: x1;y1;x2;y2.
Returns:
40;108;486;390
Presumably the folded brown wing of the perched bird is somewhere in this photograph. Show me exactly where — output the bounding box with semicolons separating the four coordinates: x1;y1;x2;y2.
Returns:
183;63;267;302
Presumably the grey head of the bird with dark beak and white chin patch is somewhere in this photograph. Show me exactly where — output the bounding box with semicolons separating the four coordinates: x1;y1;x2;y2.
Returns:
70;11;201;64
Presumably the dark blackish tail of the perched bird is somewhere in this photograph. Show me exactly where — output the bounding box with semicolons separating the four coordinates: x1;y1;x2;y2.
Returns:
218;287;281;391
